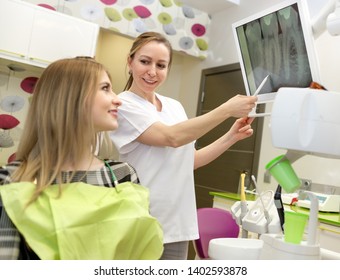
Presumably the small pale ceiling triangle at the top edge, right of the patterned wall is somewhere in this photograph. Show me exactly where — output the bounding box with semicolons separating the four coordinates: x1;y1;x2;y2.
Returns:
182;0;240;15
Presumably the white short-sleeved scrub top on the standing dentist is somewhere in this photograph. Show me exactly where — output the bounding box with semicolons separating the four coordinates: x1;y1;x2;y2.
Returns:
111;91;198;243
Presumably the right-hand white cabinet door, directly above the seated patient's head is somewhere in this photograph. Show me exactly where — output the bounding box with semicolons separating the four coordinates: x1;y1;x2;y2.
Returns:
29;7;99;63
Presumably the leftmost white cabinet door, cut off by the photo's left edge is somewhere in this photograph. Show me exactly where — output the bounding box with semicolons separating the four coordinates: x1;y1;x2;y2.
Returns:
0;0;34;58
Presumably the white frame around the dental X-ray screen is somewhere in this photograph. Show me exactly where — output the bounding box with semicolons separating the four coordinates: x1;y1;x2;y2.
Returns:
232;0;321;99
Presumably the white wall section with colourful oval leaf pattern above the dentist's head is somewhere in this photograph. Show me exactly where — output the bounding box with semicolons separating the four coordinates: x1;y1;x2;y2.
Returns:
26;0;210;57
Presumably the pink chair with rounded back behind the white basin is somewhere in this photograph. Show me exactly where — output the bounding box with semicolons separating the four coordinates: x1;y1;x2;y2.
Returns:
193;208;240;259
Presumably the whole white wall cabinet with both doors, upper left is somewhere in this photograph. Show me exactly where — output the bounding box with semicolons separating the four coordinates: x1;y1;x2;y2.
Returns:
0;0;99;67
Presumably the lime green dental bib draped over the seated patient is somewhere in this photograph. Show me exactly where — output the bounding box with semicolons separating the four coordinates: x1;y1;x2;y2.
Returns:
0;182;163;260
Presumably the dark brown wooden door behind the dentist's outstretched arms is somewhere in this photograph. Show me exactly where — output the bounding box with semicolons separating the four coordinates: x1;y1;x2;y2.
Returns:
195;63;263;207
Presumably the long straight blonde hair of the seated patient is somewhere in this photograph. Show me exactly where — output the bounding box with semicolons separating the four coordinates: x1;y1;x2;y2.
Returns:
12;57;111;200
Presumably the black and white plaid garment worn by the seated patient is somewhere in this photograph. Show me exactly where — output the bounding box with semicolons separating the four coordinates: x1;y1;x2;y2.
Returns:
0;160;139;260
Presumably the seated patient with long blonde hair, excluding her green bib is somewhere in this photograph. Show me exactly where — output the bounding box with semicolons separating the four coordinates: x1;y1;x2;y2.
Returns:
0;57;163;259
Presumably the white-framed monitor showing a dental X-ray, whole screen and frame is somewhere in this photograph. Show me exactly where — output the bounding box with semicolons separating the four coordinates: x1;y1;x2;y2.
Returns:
232;0;320;103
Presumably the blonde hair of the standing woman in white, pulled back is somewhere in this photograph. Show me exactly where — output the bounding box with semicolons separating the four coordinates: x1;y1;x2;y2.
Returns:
124;32;172;90
